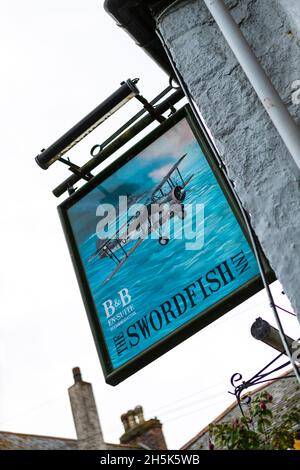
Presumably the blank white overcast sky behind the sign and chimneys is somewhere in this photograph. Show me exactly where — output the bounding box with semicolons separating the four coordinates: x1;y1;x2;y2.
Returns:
0;0;299;448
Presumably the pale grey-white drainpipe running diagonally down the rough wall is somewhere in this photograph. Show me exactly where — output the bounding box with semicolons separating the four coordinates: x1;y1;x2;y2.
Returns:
204;0;300;168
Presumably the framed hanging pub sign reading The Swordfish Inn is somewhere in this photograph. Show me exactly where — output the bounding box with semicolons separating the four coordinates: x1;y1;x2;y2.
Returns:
58;106;270;385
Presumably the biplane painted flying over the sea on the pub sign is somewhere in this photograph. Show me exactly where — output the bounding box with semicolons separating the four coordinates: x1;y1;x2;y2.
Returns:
89;154;193;284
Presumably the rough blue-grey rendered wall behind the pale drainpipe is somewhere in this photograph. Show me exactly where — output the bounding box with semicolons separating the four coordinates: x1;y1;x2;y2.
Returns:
157;0;300;319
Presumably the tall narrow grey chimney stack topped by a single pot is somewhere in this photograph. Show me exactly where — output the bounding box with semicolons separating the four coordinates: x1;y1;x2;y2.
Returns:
68;367;106;450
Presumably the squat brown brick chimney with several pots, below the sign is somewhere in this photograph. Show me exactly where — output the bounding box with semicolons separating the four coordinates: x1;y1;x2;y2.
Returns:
120;406;167;450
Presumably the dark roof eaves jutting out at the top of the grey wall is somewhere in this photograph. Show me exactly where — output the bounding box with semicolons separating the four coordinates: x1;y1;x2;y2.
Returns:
104;0;174;76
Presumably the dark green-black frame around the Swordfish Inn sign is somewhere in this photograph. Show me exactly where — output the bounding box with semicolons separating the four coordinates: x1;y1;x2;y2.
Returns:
57;105;276;385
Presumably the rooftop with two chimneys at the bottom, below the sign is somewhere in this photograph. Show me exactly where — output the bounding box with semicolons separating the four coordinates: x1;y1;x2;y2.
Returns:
0;367;167;450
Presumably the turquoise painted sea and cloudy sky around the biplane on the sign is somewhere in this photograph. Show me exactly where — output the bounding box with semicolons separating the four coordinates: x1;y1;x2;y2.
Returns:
68;118;259;369
